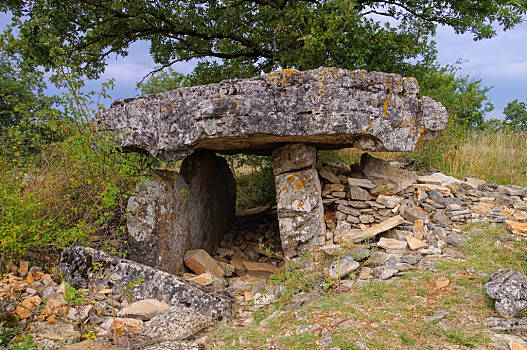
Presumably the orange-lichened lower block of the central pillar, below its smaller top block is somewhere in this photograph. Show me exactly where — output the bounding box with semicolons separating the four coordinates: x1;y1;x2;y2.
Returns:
273;148;325;258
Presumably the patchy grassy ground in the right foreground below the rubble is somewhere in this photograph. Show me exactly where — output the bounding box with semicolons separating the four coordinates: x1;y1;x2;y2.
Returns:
211;224;527;350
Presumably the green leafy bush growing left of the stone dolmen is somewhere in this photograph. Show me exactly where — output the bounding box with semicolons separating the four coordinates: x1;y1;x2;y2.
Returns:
0;69;152;268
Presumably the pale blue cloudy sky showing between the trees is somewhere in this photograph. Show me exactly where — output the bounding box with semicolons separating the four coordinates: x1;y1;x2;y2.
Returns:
0;13;527;119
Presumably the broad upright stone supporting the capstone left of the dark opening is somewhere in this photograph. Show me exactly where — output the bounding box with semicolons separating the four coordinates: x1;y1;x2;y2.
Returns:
127;151;236;273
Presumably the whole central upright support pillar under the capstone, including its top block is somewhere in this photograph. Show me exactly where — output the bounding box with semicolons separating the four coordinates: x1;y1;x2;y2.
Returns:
273;144;324;258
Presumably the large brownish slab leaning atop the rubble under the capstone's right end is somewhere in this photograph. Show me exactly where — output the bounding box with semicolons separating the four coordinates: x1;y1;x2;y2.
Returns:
360;153;417;195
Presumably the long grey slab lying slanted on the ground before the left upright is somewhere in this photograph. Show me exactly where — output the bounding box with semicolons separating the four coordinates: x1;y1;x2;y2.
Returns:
58;247;233;320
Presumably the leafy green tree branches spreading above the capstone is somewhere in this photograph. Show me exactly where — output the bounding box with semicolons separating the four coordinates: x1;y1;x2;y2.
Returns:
0;0;526;82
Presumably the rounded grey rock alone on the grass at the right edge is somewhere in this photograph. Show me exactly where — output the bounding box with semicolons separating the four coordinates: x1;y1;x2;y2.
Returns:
485;269;527;317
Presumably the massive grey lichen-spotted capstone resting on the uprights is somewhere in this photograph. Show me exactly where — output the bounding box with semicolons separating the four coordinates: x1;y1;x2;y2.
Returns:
97;68;448;160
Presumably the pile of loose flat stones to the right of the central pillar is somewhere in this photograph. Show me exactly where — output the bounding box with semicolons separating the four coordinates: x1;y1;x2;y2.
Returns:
317;153;527;280
